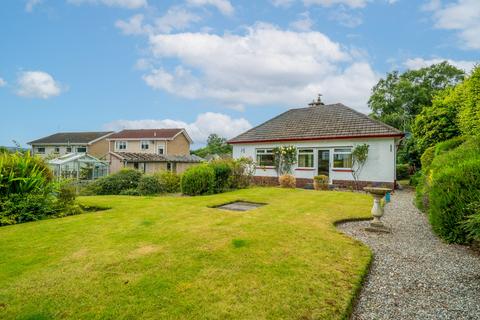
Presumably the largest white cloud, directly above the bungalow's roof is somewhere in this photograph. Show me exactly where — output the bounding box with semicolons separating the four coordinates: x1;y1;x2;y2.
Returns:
144;24;378;111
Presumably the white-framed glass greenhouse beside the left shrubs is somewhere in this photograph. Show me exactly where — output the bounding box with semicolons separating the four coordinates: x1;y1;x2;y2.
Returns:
47;153;108;181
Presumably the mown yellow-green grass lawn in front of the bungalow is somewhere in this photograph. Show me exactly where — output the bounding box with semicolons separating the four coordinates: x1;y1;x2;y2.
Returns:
0;188;371;319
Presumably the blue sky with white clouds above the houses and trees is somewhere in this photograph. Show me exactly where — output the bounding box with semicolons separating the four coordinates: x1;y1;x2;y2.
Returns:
0;0;480;146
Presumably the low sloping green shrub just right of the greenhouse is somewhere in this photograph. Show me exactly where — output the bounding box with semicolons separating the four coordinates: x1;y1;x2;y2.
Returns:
82;169;142;195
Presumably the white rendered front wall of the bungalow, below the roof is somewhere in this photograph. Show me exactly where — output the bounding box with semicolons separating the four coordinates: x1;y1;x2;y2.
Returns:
233;138;396;182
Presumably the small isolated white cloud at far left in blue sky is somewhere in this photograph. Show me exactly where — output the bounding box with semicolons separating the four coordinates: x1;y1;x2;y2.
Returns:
16;71;62;99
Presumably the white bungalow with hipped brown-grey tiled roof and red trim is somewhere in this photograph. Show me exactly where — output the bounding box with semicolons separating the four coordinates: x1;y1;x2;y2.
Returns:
228;99;404;187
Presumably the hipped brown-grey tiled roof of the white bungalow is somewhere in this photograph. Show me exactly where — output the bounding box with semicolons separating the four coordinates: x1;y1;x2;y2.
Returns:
228;103;403;143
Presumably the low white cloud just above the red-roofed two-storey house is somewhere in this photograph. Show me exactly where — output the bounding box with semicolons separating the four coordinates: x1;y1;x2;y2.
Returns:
104;112;252;144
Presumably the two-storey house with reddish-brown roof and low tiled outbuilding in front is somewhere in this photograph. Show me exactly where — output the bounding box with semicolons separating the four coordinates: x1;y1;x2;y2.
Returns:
107;128;204;173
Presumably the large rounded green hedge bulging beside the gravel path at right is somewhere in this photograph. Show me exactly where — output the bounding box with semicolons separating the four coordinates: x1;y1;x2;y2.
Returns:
417;138;480;243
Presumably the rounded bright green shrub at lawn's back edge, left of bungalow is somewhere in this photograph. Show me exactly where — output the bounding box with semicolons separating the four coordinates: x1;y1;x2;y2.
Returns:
180;164;215;196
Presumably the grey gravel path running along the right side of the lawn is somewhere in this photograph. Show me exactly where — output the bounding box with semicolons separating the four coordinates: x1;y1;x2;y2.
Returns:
338;191;480;319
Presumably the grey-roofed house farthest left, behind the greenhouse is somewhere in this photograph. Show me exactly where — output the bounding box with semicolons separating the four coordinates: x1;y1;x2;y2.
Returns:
28;131;114;158
